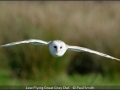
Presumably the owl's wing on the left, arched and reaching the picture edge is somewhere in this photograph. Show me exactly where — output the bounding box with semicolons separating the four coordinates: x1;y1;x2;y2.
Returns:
0;39;49;47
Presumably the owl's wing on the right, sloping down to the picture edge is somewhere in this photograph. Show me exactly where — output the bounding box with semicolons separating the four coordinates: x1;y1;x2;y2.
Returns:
68;46;120;61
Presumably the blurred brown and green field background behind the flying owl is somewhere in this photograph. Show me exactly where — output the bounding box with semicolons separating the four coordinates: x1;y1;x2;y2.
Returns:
0;1;120;86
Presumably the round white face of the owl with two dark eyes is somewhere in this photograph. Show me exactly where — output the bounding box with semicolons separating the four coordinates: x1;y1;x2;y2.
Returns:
49;40;67;57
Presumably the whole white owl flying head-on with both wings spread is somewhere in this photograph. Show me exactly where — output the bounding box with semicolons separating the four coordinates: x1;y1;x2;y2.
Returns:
0;39;120;61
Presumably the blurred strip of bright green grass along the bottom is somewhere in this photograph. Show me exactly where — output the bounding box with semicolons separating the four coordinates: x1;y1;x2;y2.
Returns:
0;70;120;86
